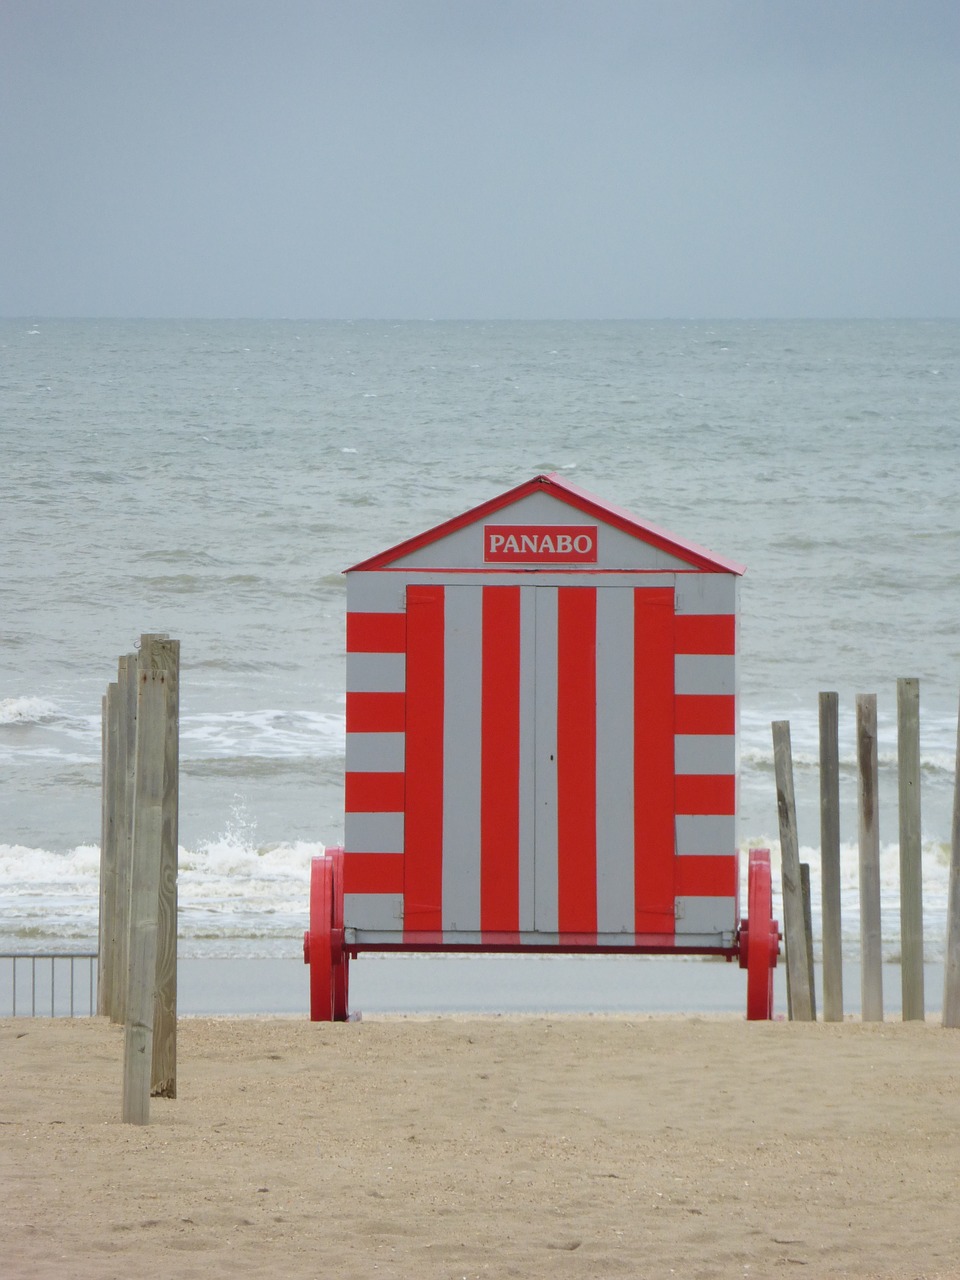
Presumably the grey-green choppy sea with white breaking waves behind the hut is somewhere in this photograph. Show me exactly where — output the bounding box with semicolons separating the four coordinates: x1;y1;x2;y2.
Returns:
0;317;960;998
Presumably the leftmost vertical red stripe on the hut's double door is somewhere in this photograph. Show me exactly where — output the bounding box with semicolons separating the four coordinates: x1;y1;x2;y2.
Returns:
403;586;444;936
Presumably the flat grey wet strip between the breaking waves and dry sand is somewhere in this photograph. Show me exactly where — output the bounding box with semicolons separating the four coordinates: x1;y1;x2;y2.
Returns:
0;952;943;1020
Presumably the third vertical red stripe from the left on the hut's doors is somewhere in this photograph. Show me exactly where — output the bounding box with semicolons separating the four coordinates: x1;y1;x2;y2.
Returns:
557;586;596;934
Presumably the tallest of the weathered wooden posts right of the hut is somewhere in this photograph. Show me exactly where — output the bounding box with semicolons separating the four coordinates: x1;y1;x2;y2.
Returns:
897;680;924;1021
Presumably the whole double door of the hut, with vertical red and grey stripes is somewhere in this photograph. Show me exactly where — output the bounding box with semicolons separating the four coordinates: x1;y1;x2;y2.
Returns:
404;585;675;942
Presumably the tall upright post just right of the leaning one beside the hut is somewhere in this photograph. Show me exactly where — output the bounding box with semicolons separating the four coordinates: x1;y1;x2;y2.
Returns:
819;692;844;1023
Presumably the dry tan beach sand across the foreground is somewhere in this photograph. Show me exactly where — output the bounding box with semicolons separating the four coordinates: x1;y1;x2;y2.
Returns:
0;1016;960;1280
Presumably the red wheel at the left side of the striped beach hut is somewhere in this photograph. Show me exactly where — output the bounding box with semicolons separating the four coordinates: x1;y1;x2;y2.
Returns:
303;849;349;1023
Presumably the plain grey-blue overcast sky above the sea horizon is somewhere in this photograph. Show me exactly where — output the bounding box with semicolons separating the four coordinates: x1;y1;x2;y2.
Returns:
0;0;960;317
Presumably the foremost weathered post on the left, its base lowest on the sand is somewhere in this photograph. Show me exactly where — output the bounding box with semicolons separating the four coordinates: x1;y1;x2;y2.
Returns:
122;671;166;1124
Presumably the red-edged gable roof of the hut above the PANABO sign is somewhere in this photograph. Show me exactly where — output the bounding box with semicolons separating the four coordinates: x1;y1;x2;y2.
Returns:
344;472;746;576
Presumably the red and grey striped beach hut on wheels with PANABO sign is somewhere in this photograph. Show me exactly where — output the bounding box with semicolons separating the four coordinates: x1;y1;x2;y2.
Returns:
307;475;776;1018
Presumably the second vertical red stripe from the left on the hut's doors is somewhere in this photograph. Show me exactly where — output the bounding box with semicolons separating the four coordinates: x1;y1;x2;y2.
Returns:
480;586;520;933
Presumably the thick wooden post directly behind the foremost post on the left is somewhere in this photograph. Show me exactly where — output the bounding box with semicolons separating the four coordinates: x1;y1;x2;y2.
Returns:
140;635;180;1098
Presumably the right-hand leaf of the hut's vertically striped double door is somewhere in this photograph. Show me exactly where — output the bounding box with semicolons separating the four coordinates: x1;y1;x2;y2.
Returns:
535;586;676;941
